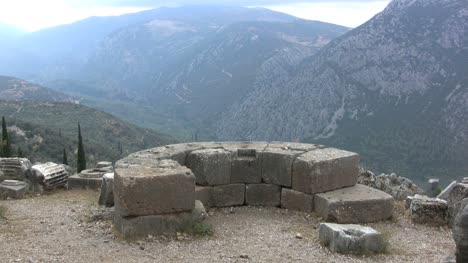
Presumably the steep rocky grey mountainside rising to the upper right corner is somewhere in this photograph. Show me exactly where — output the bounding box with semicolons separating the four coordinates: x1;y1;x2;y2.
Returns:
216;0;468;184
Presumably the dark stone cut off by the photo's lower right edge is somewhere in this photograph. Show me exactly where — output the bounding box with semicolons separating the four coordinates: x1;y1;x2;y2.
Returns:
452;202;468;263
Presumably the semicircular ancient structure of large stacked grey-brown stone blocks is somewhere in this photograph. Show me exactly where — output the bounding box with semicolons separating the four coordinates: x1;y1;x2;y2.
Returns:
113;142;393;238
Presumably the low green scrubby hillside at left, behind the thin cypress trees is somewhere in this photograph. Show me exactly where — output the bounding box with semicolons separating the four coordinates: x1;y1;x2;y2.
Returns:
0;101;174;169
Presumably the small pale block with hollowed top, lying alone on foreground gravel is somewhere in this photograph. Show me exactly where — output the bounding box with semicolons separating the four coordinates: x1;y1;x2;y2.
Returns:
319;223;386;255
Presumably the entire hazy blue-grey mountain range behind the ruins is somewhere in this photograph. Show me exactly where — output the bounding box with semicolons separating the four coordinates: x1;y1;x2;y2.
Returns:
0;0;468;186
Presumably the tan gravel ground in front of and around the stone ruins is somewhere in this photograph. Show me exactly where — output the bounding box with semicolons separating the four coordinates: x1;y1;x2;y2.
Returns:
0;190;455;263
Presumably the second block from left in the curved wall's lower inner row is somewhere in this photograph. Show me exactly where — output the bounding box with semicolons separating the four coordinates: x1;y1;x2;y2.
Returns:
211;184;245;207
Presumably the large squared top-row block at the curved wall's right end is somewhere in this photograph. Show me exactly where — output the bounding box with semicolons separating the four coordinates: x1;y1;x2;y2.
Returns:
292;148;359;194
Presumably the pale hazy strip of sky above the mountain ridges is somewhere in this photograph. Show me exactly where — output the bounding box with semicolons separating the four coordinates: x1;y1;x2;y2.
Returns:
0;0;390;31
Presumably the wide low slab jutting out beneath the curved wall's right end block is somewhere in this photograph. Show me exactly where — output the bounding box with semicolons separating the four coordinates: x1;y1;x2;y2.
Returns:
314;184;394;224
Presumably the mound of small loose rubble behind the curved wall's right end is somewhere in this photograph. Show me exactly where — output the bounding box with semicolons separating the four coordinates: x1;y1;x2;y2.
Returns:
358;169;424;201
